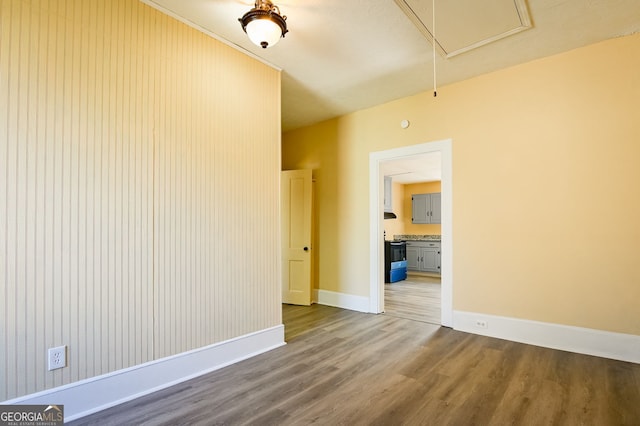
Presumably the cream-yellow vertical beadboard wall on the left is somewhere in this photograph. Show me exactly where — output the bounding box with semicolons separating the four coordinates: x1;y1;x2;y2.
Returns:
0;0;281;400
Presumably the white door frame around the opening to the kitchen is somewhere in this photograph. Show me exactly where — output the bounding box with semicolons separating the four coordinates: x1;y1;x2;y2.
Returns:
369;139;453;327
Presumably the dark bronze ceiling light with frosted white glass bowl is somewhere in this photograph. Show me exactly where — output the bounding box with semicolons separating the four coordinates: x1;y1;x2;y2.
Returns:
238;0;288;49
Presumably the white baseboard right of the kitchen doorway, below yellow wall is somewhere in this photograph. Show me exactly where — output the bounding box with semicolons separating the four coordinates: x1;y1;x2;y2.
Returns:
453;311;640;364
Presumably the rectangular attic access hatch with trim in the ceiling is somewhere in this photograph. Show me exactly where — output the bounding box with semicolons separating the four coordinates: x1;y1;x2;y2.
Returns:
395;0;531;58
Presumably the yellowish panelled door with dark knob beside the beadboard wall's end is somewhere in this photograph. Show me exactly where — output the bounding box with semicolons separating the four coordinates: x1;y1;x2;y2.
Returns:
281;170;312;305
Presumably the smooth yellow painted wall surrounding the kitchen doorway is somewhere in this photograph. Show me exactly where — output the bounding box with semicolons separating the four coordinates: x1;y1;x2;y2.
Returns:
283;34;640;335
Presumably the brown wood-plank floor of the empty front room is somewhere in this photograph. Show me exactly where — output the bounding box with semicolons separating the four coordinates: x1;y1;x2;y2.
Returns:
72;305;640;426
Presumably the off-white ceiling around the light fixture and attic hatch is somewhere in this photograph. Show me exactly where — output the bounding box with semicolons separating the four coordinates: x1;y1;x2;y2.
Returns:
142;0;640;131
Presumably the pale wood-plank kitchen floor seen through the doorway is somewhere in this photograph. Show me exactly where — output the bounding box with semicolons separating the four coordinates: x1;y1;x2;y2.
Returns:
384;273;441;325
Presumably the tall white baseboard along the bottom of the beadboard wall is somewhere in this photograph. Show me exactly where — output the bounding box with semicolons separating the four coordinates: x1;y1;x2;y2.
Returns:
2;324;285;422
